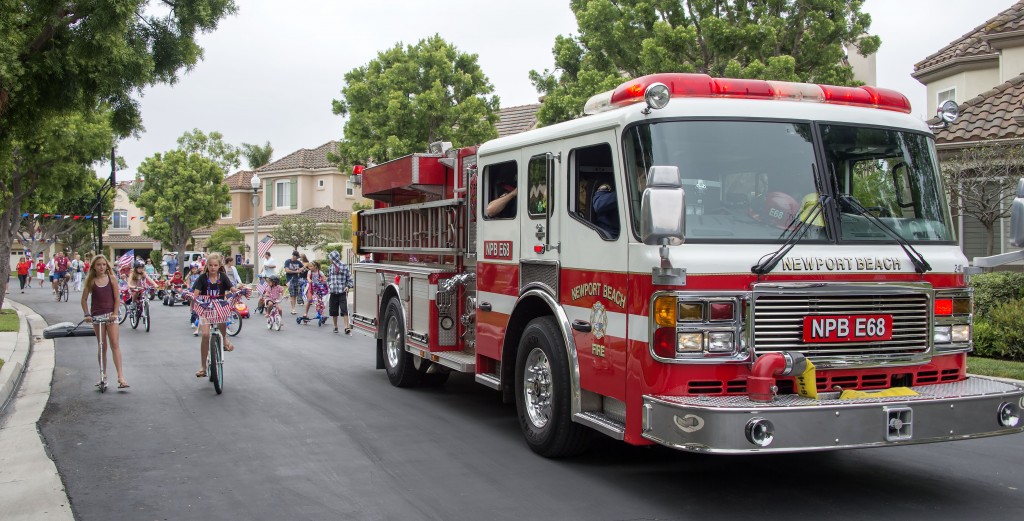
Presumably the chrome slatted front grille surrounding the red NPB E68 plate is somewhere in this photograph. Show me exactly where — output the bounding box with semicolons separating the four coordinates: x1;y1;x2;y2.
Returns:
753;286;932;357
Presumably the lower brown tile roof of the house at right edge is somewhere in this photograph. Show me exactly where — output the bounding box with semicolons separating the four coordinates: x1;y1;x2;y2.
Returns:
928;74;1024;147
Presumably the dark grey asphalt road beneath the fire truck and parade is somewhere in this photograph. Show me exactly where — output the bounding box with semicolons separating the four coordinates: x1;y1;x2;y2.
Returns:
10;290;1024;521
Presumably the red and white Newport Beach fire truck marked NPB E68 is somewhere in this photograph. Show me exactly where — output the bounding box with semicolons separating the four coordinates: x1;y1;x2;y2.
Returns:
351;74;1024;457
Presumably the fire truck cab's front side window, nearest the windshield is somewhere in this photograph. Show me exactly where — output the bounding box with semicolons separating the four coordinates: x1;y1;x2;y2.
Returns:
569;143;621;241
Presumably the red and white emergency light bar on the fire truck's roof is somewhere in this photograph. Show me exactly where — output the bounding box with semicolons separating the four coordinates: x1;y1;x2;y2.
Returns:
584;73;910;115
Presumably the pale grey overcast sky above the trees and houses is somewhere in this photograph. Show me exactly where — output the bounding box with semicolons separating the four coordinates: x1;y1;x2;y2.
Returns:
110;0;1014;180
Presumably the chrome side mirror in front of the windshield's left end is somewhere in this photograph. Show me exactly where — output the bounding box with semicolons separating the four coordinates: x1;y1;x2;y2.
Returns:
640;166;688;245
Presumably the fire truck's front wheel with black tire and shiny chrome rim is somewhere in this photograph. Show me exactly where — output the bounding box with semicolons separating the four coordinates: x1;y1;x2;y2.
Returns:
515;316;591;458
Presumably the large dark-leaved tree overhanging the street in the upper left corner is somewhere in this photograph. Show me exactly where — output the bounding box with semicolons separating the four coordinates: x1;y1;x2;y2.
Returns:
0;0;237;302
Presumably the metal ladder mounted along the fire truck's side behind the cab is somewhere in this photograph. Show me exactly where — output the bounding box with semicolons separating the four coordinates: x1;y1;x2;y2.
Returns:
356;199;465;255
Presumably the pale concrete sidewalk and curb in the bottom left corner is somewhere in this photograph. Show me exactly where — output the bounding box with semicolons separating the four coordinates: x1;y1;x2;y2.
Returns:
0;299;75;521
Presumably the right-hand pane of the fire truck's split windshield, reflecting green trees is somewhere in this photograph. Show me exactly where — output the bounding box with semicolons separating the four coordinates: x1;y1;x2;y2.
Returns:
821;125;954;243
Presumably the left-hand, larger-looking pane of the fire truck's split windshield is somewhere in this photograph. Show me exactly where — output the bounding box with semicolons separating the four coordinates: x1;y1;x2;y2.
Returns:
624;121;825;242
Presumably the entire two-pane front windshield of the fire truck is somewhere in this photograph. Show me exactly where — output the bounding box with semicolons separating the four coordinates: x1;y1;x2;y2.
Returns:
624;121;954;243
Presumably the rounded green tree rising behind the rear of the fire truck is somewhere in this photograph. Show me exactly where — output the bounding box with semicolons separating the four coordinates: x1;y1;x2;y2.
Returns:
333;35;499;164
